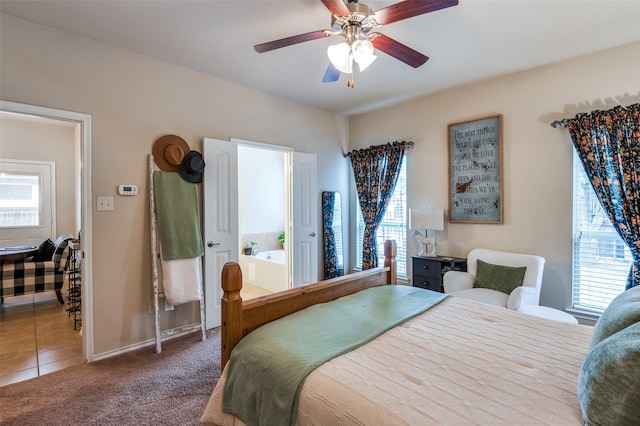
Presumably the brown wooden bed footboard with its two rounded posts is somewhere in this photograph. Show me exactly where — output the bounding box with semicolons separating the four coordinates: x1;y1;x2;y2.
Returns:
221;240;397;368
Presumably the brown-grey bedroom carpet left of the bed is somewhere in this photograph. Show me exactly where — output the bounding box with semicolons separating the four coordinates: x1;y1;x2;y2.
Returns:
0;328;220;426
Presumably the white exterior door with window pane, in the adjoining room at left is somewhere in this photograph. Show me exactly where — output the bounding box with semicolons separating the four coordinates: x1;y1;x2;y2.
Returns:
0;160;56;246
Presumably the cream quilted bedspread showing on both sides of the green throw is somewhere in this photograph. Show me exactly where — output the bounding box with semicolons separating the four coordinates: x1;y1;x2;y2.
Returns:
201;297;592;425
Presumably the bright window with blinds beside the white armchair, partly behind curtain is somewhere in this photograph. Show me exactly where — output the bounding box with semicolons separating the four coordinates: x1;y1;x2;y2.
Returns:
573;151;632;314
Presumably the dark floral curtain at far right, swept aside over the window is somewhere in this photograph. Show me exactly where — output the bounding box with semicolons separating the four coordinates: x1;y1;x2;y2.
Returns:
567;104;640;289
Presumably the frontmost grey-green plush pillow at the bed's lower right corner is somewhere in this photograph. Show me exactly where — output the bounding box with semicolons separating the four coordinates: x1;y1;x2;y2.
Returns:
578;323;640;426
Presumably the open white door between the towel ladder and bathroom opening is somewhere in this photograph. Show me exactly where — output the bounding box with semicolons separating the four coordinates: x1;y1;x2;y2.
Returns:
203;138;240;329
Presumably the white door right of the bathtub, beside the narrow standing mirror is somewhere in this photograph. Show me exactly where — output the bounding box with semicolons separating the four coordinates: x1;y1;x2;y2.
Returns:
291;152;318;287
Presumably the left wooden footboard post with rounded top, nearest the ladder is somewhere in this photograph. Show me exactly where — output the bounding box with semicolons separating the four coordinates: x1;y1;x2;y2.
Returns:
220;262;242;367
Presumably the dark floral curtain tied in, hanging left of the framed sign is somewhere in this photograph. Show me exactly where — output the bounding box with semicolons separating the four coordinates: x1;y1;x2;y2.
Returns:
349;141;412;270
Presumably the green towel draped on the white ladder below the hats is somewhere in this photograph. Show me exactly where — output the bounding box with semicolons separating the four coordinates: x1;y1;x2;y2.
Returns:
153;172;204;260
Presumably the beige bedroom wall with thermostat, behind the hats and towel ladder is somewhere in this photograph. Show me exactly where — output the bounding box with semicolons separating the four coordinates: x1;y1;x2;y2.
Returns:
0;15;349;355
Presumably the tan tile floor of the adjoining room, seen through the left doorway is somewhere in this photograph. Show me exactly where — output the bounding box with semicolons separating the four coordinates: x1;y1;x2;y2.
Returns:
0;292;82;386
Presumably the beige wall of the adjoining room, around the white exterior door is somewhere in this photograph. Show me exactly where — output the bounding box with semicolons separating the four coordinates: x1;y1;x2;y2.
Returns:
0;115;79;240
